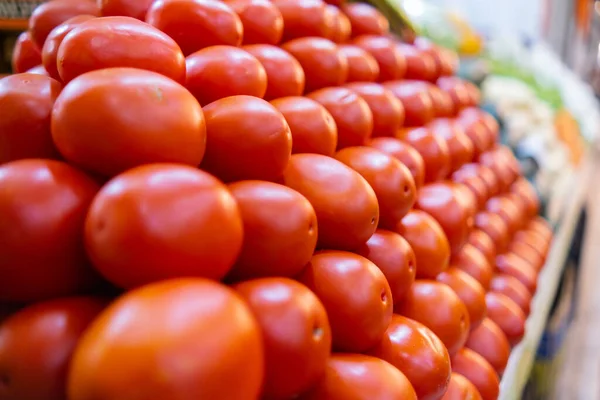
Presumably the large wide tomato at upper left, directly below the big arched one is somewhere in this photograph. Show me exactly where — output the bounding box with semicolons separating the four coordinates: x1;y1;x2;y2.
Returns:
51;68;206;177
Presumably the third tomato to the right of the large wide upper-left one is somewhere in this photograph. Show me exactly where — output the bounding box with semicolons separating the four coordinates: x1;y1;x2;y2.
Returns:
308;87;373;149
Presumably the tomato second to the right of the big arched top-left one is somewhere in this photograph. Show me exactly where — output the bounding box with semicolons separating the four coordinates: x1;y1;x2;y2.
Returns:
244;44;305;100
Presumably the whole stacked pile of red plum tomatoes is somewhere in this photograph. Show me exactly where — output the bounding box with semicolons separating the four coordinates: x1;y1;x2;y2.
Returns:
0;0;552;400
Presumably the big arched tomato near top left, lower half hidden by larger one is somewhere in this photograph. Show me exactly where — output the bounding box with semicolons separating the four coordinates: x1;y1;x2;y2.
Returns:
57;17;186;83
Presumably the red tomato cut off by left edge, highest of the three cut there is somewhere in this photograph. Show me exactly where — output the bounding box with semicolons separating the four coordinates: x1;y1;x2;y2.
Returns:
0;73;62;165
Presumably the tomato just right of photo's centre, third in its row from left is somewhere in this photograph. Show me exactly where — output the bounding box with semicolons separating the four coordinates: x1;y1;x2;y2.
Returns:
283;154;379;250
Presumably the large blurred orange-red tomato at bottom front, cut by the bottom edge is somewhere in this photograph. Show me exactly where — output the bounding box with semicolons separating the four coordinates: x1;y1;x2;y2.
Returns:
68;278;264;400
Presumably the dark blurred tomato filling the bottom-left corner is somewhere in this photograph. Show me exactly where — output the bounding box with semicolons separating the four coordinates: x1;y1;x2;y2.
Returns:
0;297;105;400
